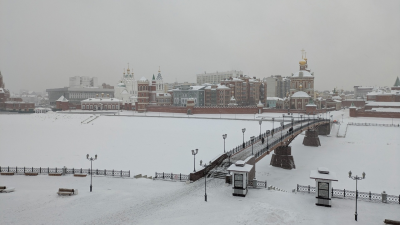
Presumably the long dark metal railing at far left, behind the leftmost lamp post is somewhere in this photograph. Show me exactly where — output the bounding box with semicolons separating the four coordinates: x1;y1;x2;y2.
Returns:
0;166;131;177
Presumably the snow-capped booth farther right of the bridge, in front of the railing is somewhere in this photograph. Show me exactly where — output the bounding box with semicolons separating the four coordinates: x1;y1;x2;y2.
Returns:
310;167;338;207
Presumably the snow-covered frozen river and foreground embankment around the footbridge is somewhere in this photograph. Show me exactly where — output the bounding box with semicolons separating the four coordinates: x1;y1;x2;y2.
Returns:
0;110;400;224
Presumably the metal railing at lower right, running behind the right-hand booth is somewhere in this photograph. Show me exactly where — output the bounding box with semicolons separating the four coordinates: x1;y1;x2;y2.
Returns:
297;185;400;204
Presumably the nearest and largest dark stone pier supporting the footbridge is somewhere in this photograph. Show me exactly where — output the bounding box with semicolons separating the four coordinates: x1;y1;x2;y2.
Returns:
270;146;296;170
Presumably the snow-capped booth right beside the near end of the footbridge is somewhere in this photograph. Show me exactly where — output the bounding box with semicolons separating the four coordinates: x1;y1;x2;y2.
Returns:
228;160;253;197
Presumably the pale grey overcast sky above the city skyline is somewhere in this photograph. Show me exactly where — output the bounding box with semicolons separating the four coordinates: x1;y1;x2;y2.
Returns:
0;0;400;92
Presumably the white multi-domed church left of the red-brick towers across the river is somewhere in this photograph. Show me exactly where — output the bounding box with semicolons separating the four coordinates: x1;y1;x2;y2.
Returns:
114;68;138;105
